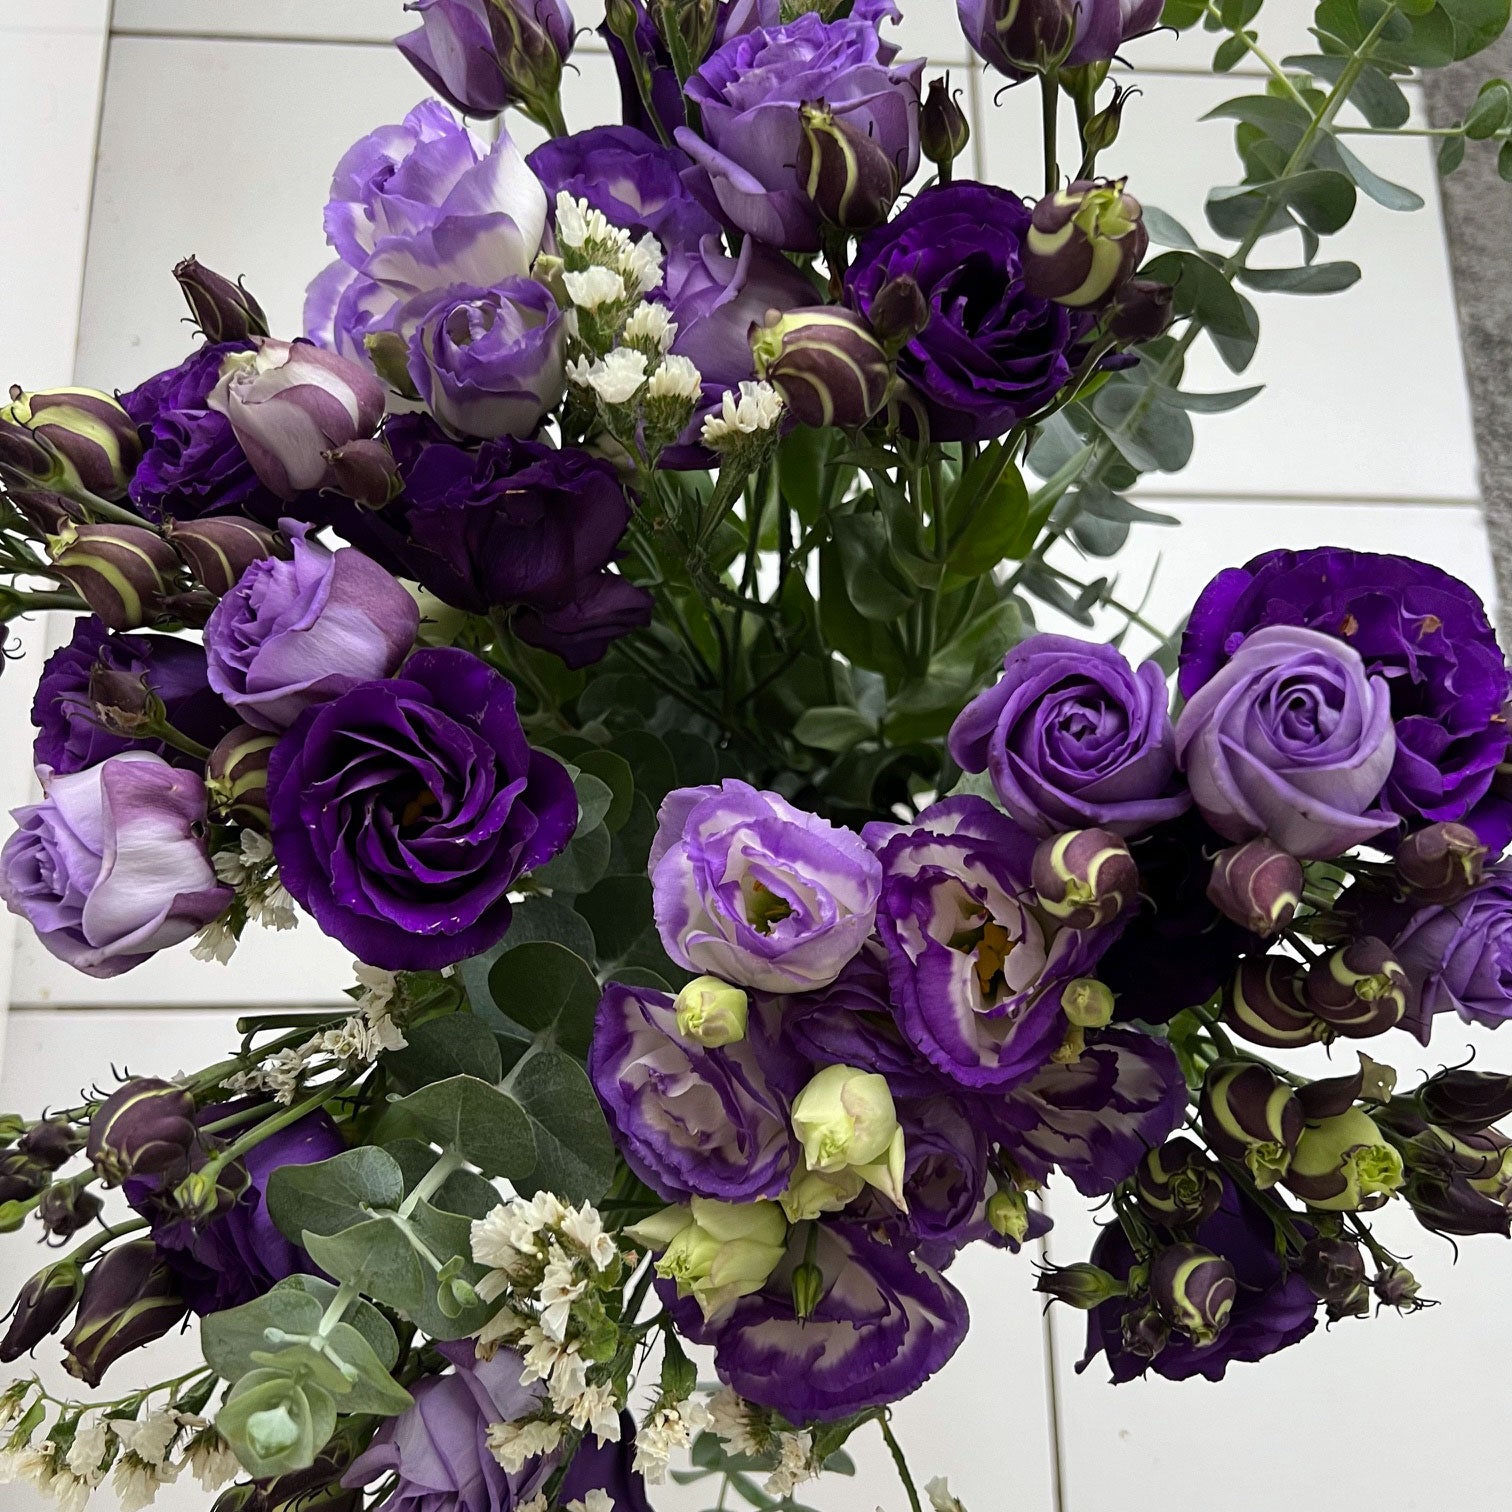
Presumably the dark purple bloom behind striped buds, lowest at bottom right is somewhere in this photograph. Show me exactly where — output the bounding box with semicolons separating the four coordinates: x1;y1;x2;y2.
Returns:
1077;1178;1318;1383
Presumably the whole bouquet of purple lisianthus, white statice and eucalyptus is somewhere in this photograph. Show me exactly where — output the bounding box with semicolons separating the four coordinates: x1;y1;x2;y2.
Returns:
0;0;1512;1512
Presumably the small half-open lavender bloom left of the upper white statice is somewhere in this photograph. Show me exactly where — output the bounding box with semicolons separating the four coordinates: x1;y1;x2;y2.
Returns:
408;278;567;437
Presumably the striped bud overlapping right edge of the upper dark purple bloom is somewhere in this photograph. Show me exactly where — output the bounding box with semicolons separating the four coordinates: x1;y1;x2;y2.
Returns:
1022;178;1149;310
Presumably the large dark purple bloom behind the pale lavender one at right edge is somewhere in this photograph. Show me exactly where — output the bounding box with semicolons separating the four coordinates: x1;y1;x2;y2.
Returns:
1179;546;1512;853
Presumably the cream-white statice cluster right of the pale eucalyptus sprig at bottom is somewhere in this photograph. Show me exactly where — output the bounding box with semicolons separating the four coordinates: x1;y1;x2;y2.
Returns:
472;1191;620;1469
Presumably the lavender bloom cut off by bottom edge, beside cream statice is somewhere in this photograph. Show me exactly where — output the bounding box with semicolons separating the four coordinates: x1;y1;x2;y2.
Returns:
342;1340;556;1512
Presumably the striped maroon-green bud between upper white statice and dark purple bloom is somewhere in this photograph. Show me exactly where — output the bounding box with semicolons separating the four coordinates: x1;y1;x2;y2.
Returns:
750;305;892;431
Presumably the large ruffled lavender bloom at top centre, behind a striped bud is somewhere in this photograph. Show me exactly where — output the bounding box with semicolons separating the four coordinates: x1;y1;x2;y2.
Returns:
676;6;924;251
